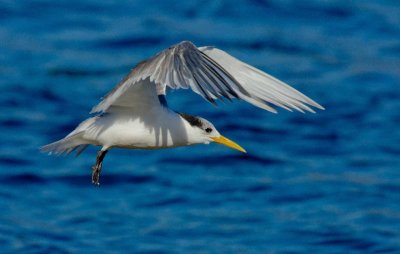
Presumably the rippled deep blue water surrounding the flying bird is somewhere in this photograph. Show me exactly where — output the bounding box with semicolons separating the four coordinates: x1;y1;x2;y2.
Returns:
0;0;400;253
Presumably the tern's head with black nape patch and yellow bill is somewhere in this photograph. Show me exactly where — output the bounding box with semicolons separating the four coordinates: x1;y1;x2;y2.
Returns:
180;113;246;153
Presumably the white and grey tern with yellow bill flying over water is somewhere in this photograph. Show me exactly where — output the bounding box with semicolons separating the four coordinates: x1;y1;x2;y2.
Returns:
41;41;324;185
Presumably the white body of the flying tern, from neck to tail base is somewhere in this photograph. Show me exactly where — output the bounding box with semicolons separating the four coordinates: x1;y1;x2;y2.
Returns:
83;107;200;149
